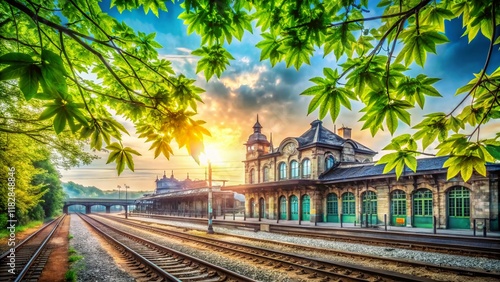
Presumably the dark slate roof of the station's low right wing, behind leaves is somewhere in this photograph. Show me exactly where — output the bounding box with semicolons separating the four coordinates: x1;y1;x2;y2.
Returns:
320;157;500;182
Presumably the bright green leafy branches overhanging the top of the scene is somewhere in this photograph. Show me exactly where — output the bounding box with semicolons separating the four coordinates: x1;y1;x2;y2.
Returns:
0;0;500;180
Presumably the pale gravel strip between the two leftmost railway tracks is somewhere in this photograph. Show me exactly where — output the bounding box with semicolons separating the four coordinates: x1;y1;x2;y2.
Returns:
69;214;135;282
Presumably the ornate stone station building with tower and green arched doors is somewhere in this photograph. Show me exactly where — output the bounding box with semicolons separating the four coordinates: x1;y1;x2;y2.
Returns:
222;118;500;230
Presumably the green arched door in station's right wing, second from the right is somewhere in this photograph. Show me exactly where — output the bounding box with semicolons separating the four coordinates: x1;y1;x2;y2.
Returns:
413;189;433;228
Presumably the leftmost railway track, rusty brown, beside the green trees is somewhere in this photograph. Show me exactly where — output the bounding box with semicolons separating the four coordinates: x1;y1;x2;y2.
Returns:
0;215;65;281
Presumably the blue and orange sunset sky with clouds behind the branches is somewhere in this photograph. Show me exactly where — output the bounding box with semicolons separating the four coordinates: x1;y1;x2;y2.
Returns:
56;1;500;191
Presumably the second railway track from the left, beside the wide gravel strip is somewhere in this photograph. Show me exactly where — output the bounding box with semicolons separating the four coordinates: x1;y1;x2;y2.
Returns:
78;214;254;282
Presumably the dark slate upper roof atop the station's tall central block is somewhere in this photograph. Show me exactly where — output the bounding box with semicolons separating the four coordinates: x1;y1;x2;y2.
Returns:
295;120;376;154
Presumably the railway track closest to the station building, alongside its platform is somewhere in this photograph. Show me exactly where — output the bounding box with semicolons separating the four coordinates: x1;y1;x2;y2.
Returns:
130;215;500;258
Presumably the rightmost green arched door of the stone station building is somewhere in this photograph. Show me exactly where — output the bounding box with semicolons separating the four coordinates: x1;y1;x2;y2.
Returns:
448;186;470;229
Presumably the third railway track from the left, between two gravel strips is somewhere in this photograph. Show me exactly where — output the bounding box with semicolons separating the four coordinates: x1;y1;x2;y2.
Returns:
91;214;458;281
